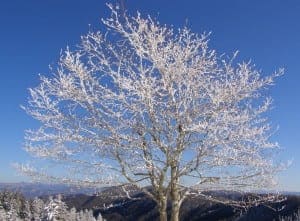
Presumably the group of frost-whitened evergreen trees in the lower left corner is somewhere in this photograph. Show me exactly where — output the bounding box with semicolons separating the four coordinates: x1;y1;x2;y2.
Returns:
0;191;104;221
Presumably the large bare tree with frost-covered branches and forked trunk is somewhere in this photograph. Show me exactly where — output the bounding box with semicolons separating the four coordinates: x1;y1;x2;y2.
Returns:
20;5;282;221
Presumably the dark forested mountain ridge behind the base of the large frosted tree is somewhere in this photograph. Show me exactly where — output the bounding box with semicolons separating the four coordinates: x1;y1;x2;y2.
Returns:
64;187;300;221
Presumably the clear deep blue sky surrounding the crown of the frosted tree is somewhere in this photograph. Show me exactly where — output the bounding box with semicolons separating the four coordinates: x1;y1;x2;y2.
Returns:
0;0;300;191
